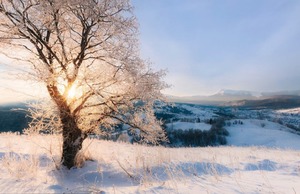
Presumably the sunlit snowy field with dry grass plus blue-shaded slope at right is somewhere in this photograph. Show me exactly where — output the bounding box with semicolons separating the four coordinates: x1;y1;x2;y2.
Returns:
0;120;300;194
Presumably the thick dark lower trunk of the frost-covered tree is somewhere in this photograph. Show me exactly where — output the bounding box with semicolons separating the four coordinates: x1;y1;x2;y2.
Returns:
60;107;86;169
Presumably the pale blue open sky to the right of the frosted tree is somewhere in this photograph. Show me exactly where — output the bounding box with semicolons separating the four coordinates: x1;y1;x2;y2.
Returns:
132;0;300;96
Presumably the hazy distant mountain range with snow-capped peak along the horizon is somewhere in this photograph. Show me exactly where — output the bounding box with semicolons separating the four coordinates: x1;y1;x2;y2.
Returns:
168;90;300;108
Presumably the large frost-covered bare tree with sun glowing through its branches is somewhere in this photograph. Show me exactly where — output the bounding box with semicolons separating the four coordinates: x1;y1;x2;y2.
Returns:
0;0;166;168
